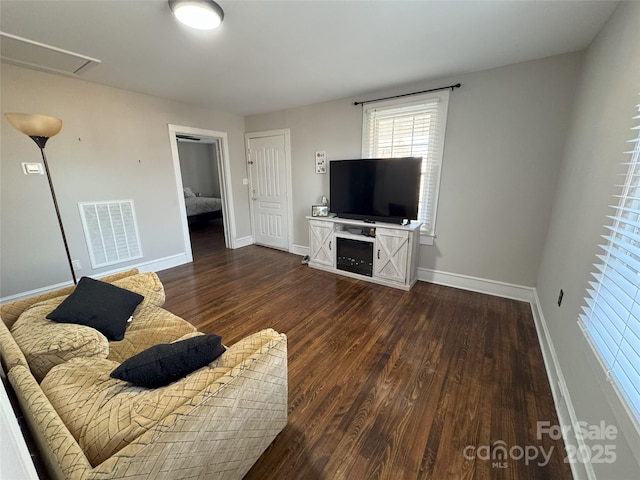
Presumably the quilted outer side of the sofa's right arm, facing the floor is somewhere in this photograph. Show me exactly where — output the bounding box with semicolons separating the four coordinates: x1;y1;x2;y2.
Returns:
87;331;288;480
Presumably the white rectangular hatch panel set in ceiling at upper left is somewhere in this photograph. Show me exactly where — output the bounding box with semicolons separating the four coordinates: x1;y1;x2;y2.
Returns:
0;32;102;76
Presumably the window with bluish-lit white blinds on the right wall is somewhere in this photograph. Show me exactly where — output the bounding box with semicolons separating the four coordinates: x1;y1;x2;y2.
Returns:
580;99;640;421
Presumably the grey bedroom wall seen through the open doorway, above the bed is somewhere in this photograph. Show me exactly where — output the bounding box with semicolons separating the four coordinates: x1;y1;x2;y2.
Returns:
178;142;220;197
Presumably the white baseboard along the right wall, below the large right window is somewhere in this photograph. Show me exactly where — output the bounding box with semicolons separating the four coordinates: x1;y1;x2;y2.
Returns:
531;288;596;480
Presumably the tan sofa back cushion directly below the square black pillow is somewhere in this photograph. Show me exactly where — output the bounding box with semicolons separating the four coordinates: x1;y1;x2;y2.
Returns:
11;297;109;382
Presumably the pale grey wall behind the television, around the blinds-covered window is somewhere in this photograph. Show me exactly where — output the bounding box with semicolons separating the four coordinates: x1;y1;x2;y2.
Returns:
245;53;581;287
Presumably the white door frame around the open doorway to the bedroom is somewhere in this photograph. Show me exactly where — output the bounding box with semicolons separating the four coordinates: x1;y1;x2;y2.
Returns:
168;124;236;262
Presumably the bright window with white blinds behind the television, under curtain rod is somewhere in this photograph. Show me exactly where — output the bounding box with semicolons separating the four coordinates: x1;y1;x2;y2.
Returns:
362;91;449;236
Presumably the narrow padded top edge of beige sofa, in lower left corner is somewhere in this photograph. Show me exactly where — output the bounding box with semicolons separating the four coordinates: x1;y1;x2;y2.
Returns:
8;365;91;480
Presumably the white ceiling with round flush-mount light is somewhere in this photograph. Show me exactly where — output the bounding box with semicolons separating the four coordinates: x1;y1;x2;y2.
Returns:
0;0;618;115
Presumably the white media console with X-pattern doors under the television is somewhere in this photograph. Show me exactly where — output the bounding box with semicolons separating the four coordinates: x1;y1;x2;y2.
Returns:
307;217;420;290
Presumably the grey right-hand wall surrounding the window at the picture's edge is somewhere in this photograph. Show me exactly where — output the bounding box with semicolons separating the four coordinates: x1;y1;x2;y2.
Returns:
537;2;640;479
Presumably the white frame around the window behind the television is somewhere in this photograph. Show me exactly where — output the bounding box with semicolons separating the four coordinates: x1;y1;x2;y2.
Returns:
361;90;450;245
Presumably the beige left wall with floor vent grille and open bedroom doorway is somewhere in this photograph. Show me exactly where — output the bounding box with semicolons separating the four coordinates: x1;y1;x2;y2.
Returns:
0;64;251;297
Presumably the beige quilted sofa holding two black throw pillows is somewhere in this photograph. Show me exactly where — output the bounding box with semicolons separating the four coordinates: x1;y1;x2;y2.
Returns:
0;270;287;479
